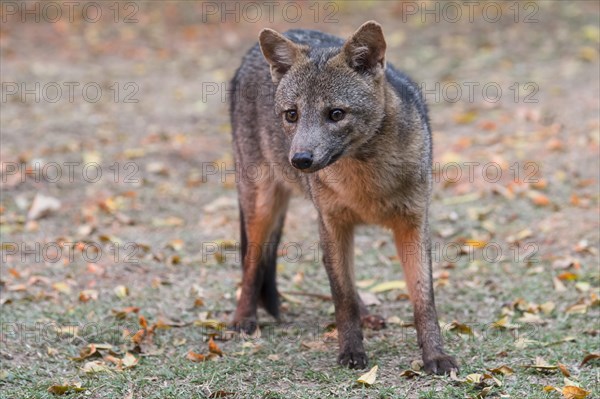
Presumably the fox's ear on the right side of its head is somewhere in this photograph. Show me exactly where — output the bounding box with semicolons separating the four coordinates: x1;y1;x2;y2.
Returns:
342;21;386;72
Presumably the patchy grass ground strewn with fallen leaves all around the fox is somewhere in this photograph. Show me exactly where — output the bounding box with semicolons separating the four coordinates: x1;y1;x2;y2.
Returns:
0;2;600;399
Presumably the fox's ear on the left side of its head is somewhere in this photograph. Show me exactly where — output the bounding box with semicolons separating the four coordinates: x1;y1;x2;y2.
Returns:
258;28;300;83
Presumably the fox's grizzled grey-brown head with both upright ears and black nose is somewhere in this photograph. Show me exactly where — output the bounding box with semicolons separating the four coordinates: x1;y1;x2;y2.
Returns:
259;21;386;172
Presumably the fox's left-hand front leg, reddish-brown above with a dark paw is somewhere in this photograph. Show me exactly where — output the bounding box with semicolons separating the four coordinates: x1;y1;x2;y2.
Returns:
319;217;368;369
